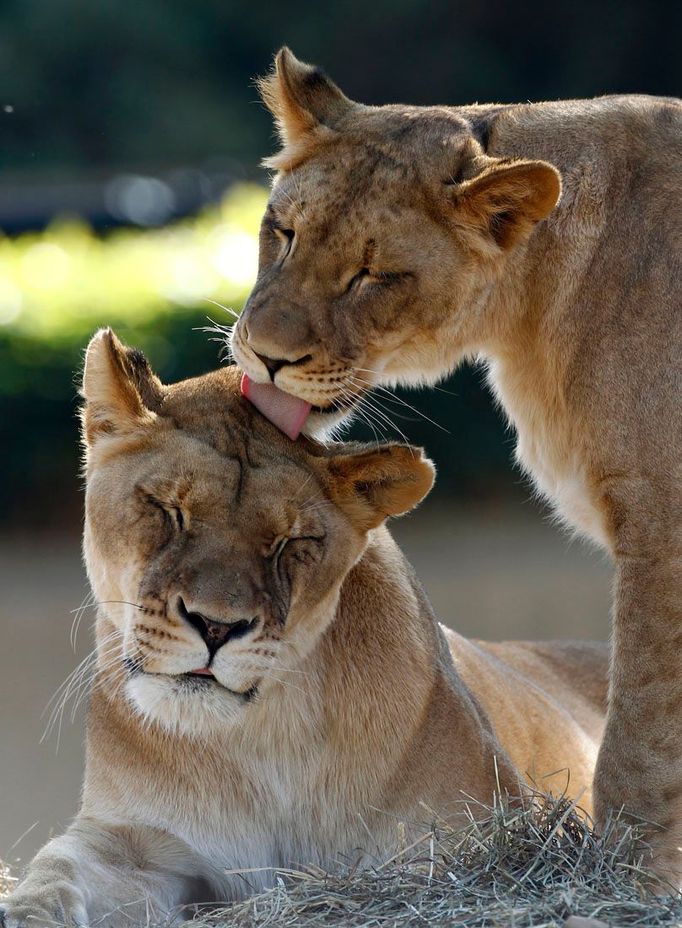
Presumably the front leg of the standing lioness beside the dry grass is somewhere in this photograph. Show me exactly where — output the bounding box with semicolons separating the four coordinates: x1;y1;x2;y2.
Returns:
595;548;682;885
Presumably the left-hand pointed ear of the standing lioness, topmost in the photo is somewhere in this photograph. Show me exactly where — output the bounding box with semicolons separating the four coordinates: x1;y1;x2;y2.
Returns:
258;47;354;161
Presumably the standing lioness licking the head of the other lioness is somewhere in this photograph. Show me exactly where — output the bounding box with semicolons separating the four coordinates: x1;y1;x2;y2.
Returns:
232;50;682;876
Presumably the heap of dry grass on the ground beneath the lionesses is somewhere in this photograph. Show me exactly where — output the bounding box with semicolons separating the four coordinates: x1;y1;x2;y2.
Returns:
0;796;682;928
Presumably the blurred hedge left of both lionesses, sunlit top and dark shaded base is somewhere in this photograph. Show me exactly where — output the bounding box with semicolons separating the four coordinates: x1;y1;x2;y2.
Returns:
0;185;260;524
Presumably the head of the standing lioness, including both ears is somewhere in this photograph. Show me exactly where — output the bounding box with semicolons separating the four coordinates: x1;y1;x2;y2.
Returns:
232;49;561;431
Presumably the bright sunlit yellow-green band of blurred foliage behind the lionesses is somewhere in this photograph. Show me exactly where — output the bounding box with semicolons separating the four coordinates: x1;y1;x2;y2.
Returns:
0;184;267;356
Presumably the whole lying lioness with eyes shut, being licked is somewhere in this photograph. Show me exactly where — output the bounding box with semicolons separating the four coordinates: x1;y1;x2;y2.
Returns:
4;331;607;928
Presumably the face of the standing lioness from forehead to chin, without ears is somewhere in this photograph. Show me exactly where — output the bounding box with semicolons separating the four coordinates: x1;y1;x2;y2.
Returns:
232;133;470;426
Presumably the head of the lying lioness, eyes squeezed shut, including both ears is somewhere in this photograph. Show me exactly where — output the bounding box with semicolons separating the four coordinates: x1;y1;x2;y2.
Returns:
82;330;433;734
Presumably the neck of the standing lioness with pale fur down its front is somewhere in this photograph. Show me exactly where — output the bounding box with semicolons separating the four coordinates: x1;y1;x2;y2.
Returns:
452;100;627;547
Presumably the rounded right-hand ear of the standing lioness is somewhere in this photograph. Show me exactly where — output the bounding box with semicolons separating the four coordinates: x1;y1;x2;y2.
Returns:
452;160;561;250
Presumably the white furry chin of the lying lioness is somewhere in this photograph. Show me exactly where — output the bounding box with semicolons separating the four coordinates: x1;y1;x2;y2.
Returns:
126;673;257;740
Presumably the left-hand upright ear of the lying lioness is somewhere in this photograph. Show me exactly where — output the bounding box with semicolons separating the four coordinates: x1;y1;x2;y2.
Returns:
81;329;163;445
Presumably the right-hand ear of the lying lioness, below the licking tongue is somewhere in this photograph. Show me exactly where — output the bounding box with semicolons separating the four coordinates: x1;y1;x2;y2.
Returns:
328;444;436;531
